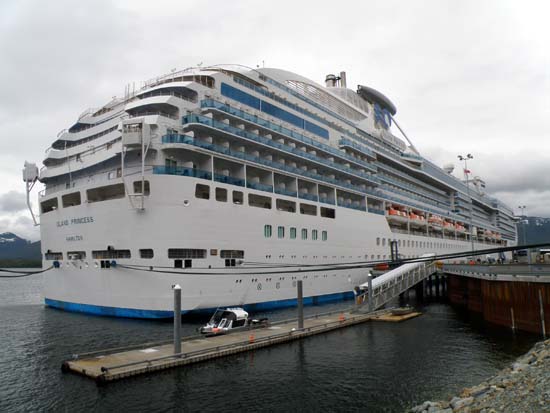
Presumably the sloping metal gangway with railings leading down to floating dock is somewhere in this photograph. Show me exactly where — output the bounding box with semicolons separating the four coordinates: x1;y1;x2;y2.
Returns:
356;253;436;311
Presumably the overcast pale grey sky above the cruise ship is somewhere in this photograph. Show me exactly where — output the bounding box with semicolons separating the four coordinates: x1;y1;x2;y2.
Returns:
0;0;550;240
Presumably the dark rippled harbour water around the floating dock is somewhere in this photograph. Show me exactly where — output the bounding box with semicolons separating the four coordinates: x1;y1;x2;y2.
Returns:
0;275;538;412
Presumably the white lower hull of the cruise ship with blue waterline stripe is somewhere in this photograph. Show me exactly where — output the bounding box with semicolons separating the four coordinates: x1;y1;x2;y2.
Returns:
42;176;492;318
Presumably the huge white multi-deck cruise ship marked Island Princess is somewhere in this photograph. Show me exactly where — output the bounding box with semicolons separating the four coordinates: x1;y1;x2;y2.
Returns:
24;65;517;318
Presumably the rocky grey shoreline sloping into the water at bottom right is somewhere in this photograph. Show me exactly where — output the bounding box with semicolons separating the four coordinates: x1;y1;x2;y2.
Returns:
407;339;550;413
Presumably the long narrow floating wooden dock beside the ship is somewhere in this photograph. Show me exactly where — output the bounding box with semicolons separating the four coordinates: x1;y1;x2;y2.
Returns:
62;310;419;384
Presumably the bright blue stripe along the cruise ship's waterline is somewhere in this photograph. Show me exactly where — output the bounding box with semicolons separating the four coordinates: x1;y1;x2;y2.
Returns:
44;291;353;319
